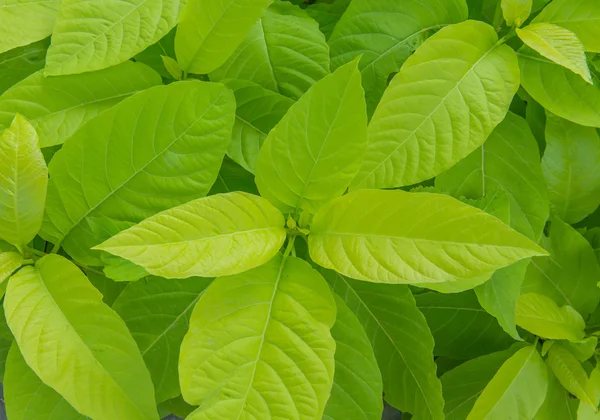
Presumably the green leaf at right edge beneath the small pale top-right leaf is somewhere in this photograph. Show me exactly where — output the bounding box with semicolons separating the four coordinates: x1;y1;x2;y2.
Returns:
518;46;600;127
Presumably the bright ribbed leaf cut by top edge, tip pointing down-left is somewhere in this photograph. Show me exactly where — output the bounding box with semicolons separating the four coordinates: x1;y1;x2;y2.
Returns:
44;0;179;76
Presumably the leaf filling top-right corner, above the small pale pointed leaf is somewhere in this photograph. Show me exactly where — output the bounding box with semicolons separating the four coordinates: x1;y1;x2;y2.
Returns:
533;0;600;53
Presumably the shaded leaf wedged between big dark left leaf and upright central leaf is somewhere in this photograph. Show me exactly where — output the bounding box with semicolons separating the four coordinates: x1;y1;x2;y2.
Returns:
224;79;294;173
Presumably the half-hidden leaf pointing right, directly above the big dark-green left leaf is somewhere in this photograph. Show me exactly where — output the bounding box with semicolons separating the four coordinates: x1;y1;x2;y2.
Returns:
0;62;162;147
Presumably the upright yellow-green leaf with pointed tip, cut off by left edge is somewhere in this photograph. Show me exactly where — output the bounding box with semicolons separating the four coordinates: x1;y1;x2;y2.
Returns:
0;114;48;249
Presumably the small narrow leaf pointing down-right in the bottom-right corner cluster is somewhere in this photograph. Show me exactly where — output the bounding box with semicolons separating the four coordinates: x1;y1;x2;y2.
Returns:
546;343;594;405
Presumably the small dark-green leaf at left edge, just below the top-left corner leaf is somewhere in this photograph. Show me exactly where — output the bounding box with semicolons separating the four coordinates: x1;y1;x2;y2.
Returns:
0;38;50;94
